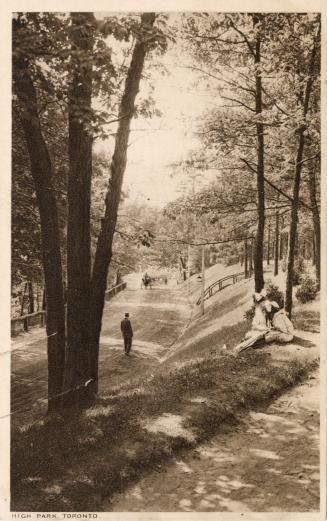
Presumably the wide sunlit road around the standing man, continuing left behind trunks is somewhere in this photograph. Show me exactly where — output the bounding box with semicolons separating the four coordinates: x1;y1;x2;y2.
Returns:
11;282;190;414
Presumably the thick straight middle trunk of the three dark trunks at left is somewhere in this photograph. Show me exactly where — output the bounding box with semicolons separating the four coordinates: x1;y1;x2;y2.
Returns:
65;13;94;407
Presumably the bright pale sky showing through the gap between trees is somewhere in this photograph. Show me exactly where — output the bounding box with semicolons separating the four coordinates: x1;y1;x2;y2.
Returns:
95;13;223;207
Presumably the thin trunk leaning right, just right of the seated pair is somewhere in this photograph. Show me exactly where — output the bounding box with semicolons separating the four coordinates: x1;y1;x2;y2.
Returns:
285;24;320;316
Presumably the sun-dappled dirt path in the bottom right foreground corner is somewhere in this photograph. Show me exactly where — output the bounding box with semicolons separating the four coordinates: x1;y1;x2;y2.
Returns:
104;374;319;512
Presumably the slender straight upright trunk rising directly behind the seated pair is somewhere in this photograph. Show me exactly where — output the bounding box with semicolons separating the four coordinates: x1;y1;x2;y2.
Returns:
253;15;265;293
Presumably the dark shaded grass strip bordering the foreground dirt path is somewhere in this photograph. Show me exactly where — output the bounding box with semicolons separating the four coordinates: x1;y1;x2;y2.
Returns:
11;351;318;511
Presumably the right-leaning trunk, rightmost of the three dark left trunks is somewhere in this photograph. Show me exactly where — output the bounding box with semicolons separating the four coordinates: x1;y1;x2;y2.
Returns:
90;13;155;391
